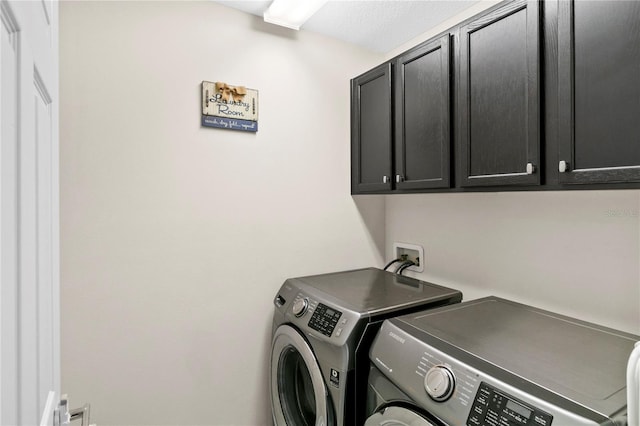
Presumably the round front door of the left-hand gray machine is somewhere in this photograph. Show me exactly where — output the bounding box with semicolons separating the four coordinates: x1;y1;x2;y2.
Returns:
271;325;335;426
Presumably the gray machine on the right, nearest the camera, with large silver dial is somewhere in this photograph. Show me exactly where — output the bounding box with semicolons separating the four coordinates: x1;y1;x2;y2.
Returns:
365;297;640;426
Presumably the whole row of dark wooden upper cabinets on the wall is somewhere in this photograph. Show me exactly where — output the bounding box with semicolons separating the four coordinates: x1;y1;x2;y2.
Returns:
351;0;640;194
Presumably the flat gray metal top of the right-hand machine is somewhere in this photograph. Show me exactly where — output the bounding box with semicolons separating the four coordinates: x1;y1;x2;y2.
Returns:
391;297;640;414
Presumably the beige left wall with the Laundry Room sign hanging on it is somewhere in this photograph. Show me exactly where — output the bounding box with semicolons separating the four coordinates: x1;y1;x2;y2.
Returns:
60;1;384;425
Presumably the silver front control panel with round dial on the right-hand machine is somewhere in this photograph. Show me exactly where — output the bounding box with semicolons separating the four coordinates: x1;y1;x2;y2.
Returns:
369;319;608;426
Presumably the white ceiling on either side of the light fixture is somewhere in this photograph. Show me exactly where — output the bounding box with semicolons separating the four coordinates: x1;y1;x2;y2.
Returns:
214;0;479;53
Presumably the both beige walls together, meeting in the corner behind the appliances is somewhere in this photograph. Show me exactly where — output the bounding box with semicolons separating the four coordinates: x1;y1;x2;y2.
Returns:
60;1;640;425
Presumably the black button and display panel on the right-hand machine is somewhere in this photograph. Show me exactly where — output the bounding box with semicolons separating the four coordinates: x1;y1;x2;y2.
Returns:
467;382;553;426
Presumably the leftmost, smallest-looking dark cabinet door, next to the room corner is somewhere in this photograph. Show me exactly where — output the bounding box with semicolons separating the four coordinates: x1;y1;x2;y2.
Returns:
351;63;393;194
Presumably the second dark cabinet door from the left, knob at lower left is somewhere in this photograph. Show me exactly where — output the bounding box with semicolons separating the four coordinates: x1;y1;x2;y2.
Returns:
395;34;450;189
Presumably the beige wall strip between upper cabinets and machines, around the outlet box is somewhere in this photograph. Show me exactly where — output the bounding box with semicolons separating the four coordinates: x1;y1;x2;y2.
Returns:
386;190;640;334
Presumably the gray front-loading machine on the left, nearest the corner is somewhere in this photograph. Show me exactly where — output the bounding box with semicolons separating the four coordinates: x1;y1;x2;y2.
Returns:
270;268;462;426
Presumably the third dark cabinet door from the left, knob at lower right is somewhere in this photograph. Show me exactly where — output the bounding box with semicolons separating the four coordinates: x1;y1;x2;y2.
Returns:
458;1;540;186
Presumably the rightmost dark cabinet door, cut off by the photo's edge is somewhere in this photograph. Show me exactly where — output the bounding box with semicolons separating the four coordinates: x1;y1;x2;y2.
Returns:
558;1;640;184
